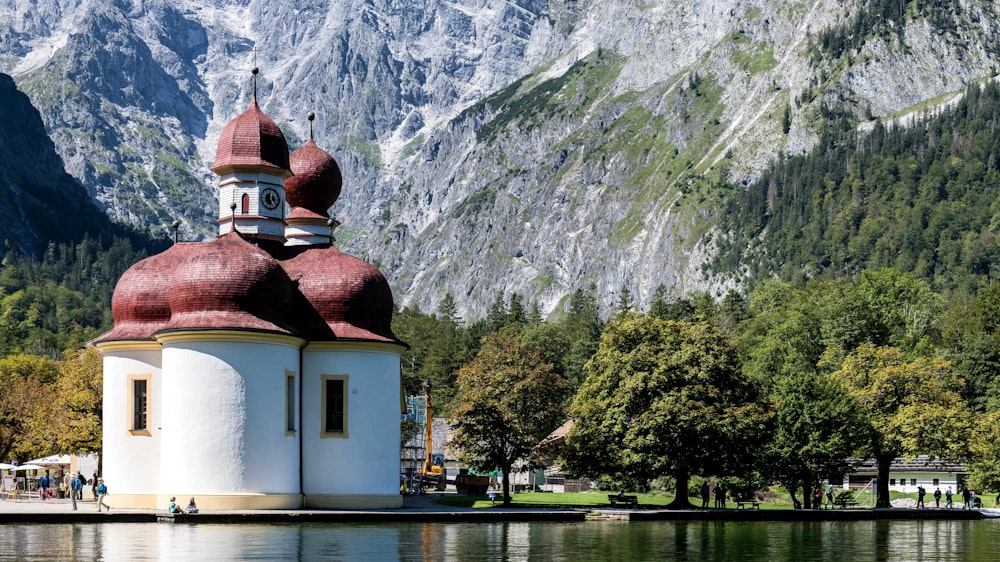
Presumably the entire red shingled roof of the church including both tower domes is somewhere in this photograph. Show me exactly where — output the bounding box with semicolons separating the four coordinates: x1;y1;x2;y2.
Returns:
100;92;401;343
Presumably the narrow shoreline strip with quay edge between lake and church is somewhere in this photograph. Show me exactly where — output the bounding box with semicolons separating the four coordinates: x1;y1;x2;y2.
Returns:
0;494;1000;524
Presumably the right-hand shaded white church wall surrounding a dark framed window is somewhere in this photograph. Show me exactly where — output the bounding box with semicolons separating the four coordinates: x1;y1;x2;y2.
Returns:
302;344;400;507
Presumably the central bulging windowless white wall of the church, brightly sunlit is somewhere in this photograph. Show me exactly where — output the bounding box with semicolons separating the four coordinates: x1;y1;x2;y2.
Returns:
160;333;299;503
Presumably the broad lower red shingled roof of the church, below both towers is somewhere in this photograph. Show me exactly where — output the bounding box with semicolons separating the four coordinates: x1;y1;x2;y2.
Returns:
100;233;399;342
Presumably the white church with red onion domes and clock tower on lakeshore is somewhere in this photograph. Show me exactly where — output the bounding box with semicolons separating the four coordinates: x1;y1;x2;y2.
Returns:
95;86;405;510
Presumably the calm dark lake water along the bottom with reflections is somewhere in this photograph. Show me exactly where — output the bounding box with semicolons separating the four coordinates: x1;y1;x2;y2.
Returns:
0;520;1000;562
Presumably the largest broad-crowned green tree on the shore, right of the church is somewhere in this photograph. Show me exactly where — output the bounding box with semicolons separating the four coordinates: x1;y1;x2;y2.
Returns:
564;314;763;507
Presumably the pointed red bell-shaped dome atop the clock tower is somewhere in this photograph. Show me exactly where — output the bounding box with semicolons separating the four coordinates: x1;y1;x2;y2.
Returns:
212;97;289;177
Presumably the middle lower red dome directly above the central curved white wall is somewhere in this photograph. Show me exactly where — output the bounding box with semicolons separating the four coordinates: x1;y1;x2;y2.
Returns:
163;232;295;334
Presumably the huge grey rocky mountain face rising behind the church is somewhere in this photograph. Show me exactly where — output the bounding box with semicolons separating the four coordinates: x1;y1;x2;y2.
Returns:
0;0;1000;317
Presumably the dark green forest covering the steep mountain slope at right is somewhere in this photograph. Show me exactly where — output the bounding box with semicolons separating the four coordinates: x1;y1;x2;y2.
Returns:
712;82;1000;295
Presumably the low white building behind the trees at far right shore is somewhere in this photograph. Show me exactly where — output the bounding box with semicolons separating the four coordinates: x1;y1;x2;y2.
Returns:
843;455;969;494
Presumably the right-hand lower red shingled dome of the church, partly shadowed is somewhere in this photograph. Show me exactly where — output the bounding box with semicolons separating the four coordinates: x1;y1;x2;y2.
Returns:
284;246;399;343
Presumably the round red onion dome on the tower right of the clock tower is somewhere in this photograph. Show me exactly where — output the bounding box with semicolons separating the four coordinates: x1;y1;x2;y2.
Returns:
285;139;344;212
